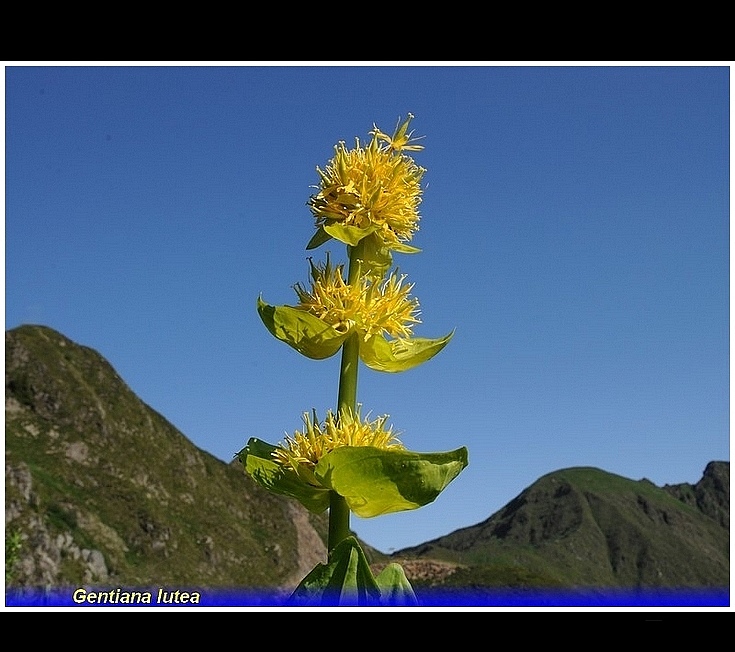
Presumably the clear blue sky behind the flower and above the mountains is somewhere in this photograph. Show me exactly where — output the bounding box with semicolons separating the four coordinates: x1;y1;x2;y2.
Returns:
5;65;730;552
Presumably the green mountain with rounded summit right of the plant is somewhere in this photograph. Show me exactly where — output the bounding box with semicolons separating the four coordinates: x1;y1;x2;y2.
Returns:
393;462;730;588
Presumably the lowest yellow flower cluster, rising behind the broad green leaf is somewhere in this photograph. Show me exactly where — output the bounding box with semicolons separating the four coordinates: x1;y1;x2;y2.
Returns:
273;409;405;471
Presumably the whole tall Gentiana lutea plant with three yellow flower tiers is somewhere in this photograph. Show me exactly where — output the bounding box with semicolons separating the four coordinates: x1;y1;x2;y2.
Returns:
238;114;467;604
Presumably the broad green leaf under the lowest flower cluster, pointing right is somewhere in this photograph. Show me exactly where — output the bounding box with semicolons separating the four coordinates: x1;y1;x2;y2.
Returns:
314;446;468;518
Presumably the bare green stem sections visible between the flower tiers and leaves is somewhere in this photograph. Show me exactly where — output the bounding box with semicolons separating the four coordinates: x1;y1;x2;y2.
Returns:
327;245;361;550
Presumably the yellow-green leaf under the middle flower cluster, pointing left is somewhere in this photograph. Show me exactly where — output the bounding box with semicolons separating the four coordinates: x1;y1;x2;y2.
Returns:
258;297;349;360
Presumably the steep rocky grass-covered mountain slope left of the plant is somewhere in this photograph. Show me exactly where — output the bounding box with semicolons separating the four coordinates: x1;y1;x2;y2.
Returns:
5;326;327;590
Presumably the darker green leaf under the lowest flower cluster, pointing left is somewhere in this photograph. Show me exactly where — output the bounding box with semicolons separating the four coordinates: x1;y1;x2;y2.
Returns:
237;437;329;514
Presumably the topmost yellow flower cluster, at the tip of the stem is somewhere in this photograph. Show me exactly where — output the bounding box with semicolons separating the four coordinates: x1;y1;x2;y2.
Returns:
309;114;426;248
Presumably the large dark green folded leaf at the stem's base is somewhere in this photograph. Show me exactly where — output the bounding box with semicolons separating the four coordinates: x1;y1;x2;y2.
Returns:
289;537;381;606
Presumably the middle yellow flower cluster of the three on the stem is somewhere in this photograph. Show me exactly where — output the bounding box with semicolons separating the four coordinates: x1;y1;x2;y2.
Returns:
294;256;420;340
